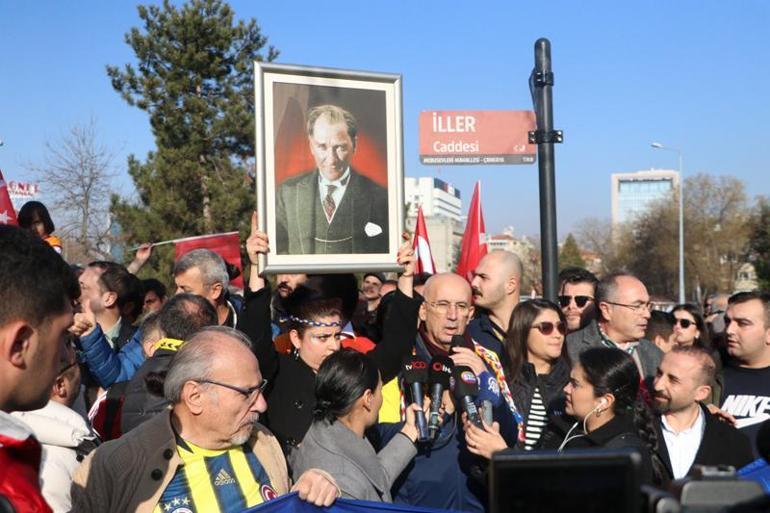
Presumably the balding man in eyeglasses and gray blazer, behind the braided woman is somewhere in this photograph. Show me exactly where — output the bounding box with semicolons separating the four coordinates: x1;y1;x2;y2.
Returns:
567;272;663;384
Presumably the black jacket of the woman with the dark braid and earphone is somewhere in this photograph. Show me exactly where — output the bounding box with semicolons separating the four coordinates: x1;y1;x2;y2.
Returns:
540;415;653;484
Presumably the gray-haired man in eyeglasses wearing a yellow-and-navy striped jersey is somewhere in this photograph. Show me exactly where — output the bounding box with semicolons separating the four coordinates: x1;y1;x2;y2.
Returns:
72;326;339;513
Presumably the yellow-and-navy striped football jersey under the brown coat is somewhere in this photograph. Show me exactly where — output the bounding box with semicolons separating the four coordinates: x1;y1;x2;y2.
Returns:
153;438;276;513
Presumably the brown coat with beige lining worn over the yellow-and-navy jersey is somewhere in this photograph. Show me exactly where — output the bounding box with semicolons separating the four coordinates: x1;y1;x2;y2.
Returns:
72;411;289;513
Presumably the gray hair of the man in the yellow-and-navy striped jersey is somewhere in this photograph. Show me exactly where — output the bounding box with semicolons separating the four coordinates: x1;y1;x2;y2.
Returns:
163;326;252;404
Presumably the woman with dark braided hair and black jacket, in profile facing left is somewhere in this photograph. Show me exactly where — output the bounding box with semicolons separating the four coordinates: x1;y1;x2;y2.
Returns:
542;347;665;484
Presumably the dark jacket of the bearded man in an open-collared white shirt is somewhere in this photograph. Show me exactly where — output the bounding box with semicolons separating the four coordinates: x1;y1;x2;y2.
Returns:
655;404;754;479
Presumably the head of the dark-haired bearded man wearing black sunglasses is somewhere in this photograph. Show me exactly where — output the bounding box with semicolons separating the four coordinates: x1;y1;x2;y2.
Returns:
558;267;599;333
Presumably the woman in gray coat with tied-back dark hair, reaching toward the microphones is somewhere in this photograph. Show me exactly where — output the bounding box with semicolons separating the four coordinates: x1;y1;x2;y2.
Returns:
291;349;418;502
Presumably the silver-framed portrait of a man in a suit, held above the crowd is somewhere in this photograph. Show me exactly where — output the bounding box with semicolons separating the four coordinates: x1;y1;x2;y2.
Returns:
255;62;404;273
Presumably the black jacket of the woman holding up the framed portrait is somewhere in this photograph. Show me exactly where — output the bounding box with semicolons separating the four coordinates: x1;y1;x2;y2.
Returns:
238;287;421;454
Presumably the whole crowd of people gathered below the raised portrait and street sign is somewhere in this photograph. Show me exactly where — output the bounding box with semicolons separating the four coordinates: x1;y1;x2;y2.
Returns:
0;198;770;513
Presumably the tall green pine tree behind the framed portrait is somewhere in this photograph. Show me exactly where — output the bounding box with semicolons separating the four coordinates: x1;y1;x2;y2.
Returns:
107;0;278;276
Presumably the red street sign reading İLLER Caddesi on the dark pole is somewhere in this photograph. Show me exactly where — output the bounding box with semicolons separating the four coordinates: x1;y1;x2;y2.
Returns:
420;110;536;166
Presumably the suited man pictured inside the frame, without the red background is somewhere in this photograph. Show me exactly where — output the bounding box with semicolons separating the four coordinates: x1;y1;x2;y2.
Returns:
276;104;388;255
